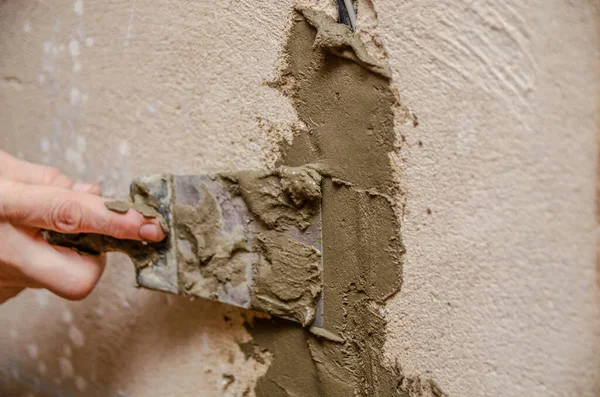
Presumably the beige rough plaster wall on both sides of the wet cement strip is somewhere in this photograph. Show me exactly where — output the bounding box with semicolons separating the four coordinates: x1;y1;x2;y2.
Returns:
0;0;600;396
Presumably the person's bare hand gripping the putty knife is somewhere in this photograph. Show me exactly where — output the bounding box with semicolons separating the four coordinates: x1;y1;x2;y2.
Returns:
0;151;165;303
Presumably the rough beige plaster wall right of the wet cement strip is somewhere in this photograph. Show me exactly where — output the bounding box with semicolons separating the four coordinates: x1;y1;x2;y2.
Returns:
378;1;600;396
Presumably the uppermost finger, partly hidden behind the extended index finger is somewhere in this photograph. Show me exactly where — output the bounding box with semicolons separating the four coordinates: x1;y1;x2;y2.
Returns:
0;150;101;194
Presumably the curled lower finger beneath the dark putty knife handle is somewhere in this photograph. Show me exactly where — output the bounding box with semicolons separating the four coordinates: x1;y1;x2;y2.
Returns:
13;230;106;300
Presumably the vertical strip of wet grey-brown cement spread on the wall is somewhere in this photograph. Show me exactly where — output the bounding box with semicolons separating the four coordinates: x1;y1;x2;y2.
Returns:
244;9;410;397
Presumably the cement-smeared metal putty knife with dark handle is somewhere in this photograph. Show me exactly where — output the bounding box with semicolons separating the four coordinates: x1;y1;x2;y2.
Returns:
44;167;323;327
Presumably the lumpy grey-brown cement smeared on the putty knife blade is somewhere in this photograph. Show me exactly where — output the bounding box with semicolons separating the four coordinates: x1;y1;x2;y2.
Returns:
173;167;322;324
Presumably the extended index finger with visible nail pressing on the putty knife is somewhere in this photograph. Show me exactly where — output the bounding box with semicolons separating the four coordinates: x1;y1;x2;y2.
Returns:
0;181;165;241
